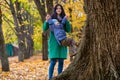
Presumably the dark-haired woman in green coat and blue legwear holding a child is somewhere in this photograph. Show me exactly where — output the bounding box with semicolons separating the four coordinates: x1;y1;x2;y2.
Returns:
43;4;71;80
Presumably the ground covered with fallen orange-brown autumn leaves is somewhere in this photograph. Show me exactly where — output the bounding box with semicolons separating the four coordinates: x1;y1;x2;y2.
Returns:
0;55;70;80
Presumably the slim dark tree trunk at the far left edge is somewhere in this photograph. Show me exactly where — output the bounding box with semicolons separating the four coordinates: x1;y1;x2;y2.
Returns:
0;6;9;71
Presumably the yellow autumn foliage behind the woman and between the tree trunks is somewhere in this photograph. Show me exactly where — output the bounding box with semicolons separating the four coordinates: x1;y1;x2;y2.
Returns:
0;0;85;51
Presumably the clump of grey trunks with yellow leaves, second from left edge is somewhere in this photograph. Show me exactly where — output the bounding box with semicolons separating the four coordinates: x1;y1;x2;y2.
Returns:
5;0;34;61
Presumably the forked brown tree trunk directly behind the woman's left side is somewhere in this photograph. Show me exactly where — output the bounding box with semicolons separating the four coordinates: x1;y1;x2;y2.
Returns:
34;0;53;60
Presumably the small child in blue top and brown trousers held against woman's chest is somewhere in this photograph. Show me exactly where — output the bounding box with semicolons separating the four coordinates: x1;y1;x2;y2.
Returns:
47;16;78;56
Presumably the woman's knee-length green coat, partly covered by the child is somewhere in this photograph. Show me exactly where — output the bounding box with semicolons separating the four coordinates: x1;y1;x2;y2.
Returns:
43;21;71;59
